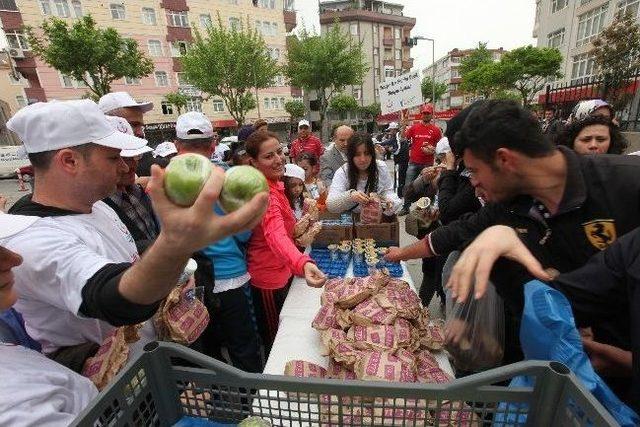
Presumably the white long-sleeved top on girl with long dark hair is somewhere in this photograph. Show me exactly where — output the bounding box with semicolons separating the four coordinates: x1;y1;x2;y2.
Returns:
327;160;402;215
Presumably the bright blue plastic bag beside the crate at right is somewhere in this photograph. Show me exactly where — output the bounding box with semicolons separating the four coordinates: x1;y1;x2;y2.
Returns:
495;280;640;426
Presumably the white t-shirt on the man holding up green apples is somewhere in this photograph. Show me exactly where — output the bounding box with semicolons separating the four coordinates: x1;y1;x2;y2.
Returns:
3;202;156;354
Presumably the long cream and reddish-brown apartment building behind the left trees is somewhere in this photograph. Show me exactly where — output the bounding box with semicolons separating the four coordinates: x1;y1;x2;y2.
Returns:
0;0;297;144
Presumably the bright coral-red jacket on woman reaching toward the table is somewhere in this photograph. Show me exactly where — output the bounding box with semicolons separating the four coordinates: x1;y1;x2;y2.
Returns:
247;181;311;289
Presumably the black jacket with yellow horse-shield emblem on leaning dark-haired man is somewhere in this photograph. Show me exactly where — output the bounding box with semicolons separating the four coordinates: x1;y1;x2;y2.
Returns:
429;147;640;272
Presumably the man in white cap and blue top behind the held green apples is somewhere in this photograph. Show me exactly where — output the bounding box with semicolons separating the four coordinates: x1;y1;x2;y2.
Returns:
176;111;263;373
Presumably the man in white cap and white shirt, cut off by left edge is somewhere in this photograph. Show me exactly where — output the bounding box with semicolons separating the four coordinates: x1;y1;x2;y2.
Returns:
0;213;98;426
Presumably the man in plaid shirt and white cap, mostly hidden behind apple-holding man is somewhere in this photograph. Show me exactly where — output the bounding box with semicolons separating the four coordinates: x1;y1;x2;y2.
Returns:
103;116;160;254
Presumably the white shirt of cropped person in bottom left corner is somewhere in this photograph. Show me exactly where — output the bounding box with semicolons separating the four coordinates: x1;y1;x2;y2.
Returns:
0;343;98;427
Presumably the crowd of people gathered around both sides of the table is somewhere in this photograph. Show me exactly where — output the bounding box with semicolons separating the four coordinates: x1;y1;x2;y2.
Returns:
0;92;640;425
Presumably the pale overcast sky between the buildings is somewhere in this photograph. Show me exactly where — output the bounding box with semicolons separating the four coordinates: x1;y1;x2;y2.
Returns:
295;0;536;69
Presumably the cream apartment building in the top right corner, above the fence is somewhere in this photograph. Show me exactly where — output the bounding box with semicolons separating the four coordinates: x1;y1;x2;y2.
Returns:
533;0;640;84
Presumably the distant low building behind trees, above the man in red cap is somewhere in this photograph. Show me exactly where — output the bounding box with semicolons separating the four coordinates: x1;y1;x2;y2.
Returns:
422;48;506;111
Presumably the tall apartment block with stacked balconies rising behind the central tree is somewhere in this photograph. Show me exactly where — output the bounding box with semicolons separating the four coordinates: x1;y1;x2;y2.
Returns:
320;0;416;110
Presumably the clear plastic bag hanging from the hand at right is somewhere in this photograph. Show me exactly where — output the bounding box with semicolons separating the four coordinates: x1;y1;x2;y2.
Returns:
443;257;504;372
